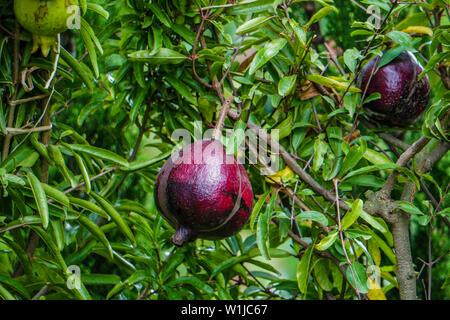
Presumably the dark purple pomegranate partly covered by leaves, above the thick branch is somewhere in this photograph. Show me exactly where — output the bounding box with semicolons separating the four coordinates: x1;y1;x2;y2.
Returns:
358;51;430;126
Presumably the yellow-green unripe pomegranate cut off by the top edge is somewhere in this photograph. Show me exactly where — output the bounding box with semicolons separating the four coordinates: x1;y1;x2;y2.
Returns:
14;0;79;57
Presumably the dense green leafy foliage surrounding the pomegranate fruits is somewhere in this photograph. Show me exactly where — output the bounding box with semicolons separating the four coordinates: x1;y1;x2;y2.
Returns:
0;0;450;300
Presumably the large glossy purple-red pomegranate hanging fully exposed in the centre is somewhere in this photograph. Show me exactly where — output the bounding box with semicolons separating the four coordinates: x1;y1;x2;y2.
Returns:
155;140;253;246
